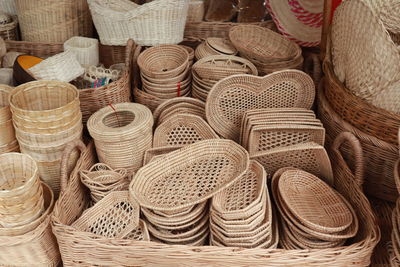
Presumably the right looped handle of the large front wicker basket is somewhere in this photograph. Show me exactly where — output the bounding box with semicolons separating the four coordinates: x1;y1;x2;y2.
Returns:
332;132;364;187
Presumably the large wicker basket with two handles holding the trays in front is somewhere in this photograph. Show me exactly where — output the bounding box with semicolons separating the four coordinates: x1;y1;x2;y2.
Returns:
52;136;380;267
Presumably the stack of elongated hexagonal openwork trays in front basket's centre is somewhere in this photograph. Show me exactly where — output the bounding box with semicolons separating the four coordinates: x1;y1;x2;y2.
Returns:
210;161;279;248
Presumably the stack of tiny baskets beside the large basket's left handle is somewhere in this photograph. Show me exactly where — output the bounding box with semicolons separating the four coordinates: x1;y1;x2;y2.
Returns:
80;163;130;203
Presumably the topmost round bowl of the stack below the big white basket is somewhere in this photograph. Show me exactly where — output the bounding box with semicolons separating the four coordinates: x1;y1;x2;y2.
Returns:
137;45;189;79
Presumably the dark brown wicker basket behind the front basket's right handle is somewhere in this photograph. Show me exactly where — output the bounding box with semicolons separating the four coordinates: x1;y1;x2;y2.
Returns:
317;77;398;202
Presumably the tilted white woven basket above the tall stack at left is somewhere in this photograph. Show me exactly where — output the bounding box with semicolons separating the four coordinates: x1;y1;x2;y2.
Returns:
28;50;84;82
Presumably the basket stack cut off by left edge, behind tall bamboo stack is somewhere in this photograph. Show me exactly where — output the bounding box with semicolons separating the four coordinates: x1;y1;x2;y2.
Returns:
0;85;19;154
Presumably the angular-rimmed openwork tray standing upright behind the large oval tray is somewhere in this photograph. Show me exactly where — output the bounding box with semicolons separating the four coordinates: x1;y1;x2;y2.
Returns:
153;114;219;147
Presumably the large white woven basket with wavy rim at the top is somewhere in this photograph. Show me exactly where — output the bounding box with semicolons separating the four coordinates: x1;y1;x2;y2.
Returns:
89;0;189;46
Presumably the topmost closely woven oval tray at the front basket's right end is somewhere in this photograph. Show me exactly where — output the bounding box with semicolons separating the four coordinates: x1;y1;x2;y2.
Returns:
278;170;353;233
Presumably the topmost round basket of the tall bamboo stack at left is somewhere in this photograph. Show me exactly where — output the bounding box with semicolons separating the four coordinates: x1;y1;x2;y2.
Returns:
10;81;79;121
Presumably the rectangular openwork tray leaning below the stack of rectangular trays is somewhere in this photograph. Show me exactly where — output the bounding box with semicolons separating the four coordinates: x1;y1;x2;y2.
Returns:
251;143;333;184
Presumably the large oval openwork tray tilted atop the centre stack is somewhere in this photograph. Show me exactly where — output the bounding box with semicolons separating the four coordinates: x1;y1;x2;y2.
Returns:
129;139;249;213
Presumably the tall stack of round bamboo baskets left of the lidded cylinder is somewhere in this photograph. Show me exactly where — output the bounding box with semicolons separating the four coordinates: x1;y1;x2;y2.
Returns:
10;81;83;196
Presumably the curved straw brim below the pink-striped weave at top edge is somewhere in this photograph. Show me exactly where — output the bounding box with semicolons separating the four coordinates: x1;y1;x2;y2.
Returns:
265;0;323;47
